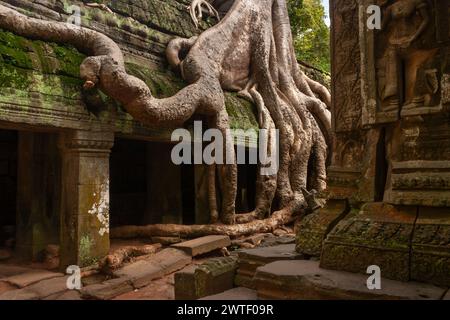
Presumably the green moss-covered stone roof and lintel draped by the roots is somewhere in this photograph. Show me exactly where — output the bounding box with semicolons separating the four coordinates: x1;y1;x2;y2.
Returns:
0;0;258;140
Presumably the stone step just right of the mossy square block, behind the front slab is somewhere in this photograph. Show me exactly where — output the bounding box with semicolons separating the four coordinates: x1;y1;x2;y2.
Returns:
235;244;303;289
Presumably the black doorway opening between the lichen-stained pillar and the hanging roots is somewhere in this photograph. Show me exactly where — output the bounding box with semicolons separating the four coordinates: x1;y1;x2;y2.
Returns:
110;138;189;227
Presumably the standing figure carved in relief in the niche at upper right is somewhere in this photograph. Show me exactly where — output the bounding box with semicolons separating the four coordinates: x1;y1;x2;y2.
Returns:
373;0;445;122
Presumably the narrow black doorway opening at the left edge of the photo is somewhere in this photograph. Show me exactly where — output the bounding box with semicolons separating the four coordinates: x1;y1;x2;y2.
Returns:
0;130;18;249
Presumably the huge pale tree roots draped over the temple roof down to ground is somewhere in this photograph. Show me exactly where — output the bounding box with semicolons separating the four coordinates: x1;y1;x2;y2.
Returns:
0;0;331;230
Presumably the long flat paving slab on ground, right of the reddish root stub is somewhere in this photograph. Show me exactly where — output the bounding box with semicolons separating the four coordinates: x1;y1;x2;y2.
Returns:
114;248;192;289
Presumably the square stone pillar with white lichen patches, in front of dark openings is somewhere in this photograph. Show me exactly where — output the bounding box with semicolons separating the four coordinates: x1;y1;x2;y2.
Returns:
59;131;114;268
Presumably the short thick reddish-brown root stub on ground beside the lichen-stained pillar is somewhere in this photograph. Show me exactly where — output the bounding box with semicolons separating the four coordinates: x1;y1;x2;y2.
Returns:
99;243;161;274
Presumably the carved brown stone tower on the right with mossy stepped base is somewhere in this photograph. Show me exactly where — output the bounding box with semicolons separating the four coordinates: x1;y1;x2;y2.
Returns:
297;0;450;285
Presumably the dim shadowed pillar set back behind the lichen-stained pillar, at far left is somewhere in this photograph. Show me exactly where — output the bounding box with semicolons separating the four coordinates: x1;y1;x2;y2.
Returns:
16;132;61;260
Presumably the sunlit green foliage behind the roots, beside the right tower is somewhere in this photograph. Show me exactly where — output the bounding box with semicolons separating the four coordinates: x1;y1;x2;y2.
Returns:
287;0;330;72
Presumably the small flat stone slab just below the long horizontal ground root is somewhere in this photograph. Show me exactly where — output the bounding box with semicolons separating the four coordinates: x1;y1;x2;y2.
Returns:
172;236;231;257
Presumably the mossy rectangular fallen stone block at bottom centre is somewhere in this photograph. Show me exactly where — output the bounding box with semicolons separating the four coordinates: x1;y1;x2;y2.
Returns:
175;256;237;300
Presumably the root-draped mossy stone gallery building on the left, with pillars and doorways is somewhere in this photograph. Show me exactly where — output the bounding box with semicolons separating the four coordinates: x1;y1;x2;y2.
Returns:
0;0;258;268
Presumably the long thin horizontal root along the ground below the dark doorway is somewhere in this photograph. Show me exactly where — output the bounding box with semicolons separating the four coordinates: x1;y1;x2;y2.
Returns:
110;208;295;239
